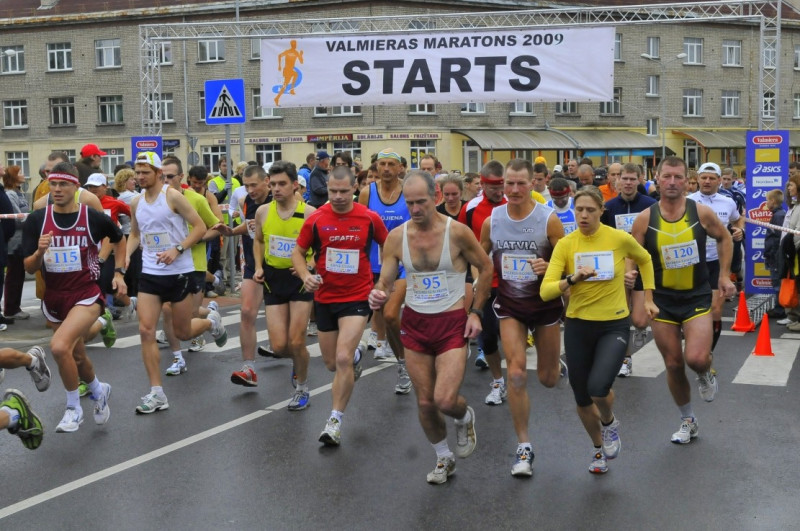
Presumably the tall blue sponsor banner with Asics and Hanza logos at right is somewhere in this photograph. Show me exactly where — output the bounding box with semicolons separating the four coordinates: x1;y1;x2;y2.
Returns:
744;131;789;294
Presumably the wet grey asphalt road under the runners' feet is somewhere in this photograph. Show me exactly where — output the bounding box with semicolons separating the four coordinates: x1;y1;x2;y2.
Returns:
0;283;800;530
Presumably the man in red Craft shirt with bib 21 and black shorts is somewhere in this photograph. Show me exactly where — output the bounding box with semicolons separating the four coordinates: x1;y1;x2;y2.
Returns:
292;166;388;446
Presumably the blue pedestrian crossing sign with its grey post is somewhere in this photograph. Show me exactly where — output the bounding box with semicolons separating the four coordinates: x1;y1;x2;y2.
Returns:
204;79;247;293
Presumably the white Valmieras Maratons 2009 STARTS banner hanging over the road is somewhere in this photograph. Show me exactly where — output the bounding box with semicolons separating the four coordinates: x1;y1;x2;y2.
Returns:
261;27;615;108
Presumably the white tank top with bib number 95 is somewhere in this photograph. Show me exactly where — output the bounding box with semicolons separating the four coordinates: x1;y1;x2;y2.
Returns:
403;217;467;314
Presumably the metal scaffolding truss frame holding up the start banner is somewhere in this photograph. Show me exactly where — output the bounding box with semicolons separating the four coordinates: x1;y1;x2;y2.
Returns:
139;0;783;135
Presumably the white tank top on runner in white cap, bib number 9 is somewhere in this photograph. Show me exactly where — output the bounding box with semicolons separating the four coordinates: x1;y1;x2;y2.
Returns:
136;184;194;275
